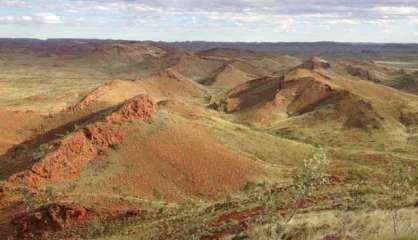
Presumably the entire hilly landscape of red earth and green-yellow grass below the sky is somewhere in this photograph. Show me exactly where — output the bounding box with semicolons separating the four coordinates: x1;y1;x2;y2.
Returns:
0;40;418;240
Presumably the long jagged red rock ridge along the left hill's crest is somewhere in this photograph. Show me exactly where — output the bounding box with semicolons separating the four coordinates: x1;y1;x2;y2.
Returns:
8;95;156;187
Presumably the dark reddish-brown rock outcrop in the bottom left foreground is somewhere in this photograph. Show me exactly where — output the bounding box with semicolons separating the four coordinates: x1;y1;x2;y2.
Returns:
12;203;89;239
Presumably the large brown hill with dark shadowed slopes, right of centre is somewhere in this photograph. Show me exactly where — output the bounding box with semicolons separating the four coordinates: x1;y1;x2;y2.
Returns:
218;59;416;128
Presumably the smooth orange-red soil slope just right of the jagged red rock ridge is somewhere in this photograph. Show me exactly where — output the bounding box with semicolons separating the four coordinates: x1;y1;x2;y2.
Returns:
100;126;258;201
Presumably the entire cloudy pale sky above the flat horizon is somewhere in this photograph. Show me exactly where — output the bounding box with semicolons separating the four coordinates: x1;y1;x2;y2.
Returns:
0;0;418;43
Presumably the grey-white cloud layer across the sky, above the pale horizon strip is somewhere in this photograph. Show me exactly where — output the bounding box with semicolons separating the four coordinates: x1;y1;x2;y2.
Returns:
0;0;418;41
